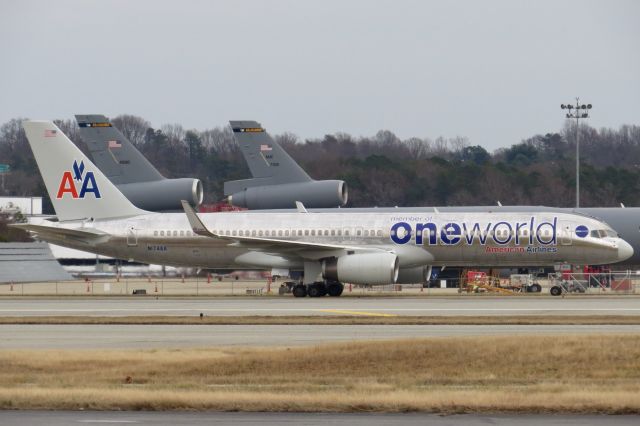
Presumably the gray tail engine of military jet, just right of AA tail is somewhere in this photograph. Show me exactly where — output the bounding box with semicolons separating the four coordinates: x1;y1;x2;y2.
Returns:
117;178;203;211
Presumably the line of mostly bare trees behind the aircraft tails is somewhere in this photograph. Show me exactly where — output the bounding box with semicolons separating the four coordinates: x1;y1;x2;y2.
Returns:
0;115;640;213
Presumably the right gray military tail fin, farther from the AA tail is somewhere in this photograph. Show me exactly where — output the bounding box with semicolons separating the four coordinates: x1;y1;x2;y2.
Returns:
224;121;312;195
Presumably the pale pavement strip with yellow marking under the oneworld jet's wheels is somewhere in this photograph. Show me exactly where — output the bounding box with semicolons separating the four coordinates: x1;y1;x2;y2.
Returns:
0;296;640;316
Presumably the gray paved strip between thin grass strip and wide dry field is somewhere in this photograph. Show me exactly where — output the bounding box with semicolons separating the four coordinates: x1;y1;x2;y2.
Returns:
0;324;640;349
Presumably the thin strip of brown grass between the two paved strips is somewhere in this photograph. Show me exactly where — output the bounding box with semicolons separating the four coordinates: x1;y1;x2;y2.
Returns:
0;315;640;325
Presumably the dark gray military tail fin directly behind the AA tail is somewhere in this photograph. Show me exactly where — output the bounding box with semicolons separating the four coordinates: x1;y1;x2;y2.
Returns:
76;114;164;185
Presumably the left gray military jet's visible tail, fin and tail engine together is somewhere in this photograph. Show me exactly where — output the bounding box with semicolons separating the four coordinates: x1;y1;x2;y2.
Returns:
76;115;203;211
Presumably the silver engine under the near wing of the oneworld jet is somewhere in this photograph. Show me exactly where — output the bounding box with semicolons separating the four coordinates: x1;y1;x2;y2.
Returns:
322;253;400;284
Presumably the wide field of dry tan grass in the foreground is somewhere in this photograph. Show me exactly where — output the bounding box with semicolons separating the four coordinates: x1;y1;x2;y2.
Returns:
0;335;640;413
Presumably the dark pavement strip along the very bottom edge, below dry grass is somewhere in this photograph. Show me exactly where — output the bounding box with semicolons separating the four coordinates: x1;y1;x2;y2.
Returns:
0;411;638;426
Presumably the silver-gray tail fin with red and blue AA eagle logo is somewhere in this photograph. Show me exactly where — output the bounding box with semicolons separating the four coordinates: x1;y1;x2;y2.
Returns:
22;121;146;221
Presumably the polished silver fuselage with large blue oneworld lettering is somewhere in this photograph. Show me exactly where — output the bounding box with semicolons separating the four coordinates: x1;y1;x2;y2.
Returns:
31;209;633;269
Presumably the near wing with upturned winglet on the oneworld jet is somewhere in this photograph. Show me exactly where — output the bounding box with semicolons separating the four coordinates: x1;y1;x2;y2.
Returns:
182;200;380;252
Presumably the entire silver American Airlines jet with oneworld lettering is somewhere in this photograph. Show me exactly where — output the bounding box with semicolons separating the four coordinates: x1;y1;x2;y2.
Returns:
14;121;633;296
